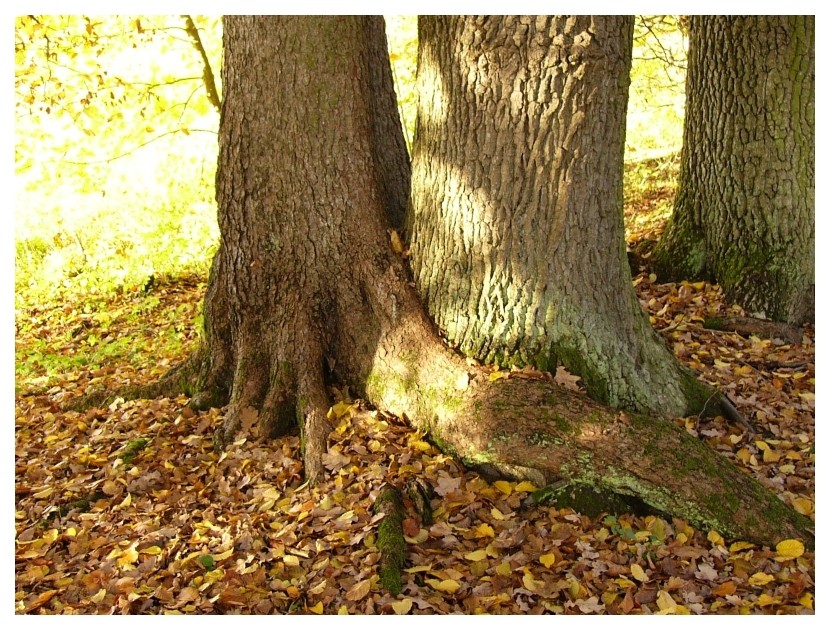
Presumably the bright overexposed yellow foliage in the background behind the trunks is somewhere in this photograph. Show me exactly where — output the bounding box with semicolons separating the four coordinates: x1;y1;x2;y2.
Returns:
15;15;685;302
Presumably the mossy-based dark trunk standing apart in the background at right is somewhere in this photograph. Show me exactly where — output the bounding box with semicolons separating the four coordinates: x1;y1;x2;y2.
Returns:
653;16;815;325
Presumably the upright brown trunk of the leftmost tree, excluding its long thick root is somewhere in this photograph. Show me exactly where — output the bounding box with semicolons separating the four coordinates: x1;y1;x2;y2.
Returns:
188;17;408;478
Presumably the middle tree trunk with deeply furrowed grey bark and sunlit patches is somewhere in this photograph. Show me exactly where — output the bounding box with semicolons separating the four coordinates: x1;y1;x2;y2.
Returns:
407;16;709;415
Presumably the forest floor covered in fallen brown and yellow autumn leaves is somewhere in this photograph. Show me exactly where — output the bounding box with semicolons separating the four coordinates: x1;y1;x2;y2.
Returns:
15;159;815;614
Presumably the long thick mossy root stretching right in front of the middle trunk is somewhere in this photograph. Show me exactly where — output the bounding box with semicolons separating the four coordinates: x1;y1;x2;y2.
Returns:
368;326;814;545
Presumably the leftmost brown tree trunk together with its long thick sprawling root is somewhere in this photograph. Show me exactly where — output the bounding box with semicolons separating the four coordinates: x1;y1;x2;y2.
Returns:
151;17;810;542
